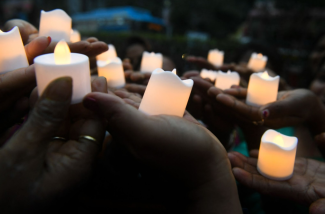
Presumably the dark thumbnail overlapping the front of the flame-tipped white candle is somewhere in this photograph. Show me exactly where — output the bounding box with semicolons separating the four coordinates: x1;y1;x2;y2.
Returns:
44;77;72;101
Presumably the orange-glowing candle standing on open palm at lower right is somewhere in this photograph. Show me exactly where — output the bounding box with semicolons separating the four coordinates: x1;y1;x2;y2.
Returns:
257;129;298;180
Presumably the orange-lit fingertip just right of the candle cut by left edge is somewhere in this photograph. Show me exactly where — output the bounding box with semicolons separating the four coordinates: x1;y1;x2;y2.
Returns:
25;36;51;64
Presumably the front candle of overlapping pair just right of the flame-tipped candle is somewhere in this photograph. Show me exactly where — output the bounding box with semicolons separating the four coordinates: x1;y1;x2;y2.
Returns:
97;57;125;88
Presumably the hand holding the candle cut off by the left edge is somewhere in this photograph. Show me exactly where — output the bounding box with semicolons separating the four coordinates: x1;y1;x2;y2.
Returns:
0;37;50;133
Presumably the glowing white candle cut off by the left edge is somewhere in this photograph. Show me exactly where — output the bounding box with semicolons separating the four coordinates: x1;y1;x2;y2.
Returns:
0;27;29;73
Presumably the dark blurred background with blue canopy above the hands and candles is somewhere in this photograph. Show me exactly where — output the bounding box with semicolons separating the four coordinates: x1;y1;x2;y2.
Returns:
0;0;325;87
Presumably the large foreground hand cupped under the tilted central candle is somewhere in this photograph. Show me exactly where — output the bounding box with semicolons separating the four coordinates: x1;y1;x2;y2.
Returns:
84;93;242;213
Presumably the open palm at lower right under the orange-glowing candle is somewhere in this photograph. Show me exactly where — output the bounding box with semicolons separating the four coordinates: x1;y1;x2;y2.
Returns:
228;150;325;214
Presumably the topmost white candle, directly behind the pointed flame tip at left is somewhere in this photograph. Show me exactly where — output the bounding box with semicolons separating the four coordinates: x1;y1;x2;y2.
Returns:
39;9;72;42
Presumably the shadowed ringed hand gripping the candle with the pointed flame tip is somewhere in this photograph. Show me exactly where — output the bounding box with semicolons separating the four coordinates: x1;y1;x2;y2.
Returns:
0;77;104;213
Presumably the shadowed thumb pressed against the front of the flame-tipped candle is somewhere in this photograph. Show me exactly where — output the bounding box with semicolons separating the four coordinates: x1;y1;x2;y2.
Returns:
6;77;72;156
